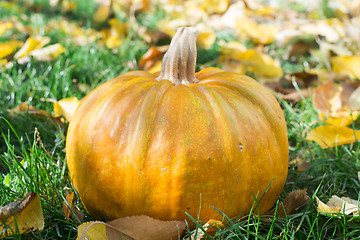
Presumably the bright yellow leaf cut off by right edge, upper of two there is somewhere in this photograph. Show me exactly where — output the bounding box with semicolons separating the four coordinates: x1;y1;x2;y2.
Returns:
330;56;360;79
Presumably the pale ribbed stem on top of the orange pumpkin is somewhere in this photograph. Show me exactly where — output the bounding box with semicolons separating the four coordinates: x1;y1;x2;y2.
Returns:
157;27;199;85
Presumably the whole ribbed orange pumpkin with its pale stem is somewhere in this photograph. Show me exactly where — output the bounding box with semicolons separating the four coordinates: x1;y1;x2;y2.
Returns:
66;27;288;224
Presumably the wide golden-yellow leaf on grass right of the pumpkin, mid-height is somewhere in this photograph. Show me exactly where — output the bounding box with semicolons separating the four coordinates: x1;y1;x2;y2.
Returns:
305;125;360;148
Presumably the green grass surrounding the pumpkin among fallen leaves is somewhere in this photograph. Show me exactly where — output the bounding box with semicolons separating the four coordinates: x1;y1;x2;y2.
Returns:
0;0;360;239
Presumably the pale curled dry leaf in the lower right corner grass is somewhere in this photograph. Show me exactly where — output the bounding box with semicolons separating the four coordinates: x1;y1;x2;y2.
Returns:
316;195;359;216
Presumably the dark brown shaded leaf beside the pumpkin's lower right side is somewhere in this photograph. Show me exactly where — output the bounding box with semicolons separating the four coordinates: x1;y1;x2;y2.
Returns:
265;189;310;218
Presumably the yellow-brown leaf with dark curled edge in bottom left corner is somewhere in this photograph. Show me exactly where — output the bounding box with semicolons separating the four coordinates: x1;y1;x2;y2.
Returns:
0;192;44;238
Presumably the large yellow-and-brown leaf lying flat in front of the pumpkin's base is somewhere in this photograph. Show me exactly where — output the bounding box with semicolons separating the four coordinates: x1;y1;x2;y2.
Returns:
77;216;186;240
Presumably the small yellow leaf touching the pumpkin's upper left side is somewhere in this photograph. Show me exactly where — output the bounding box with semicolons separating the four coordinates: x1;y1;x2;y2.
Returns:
54;97;81;122
